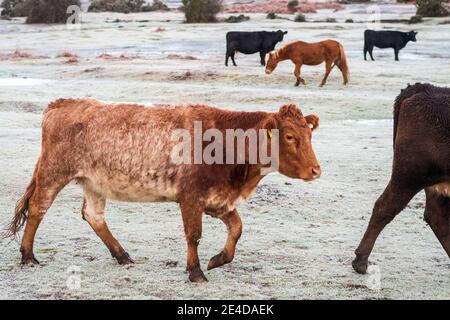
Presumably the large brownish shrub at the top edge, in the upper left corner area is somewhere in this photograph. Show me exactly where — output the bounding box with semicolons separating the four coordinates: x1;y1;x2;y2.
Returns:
24;0;81;23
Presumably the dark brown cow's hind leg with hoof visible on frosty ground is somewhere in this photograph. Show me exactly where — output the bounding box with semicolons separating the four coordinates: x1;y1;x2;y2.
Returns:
352;180;419;273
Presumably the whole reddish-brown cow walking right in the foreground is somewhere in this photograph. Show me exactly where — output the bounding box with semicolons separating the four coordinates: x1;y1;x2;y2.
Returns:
3;99;321;282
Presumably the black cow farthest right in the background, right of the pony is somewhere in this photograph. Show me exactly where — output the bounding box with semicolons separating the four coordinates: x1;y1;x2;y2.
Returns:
364;30;417;61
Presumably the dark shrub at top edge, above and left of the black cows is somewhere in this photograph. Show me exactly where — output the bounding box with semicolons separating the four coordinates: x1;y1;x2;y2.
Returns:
182;0;222;23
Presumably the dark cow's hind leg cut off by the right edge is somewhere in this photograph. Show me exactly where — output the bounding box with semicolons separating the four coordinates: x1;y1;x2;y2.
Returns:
425;189;450;257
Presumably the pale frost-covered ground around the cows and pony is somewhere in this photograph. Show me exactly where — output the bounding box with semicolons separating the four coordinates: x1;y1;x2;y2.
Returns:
0;6;450;299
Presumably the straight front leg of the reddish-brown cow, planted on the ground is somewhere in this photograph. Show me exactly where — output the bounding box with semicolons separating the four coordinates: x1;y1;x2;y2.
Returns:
180;201;208;283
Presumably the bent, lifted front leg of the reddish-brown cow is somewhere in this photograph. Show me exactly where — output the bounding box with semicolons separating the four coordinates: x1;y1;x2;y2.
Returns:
207;209;242;270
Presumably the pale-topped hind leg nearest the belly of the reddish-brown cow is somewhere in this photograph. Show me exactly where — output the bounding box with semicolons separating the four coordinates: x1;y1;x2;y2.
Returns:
82;188;134;264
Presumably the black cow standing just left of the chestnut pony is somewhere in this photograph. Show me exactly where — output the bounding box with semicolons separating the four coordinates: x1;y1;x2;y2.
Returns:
225;30;287;66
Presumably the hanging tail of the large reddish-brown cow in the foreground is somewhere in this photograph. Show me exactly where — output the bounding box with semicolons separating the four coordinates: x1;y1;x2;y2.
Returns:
1;160;39;238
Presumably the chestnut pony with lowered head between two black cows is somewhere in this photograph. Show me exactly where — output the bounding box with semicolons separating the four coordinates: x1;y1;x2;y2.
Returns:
266;40;350;87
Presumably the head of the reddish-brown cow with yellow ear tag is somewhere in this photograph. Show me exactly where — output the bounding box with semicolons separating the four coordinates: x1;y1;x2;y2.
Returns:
268;104;321;181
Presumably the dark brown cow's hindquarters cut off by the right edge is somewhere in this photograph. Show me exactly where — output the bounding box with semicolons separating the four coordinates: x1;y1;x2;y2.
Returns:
353;83;450;273
